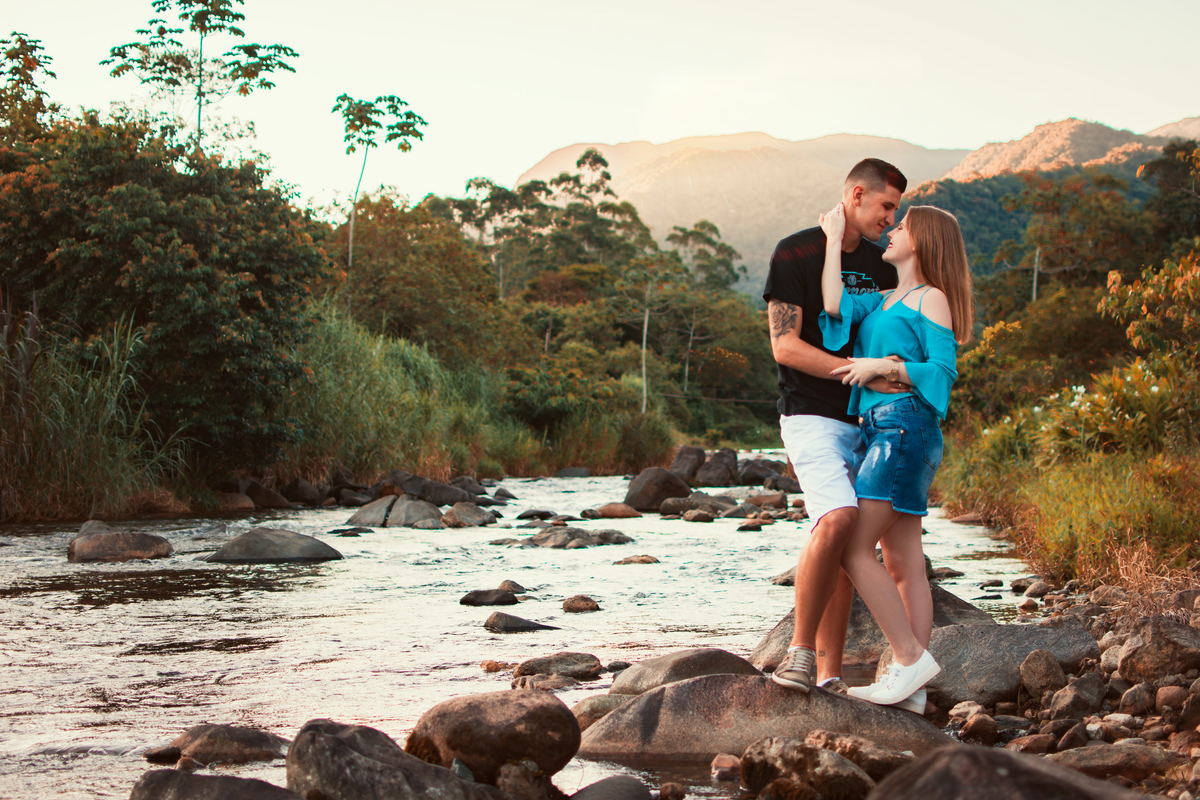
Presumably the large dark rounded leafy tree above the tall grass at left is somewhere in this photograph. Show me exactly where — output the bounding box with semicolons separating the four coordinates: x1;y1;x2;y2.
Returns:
0;118;329;467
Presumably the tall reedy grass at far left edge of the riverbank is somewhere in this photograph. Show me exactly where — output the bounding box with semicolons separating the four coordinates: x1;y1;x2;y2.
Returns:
0;311;185;522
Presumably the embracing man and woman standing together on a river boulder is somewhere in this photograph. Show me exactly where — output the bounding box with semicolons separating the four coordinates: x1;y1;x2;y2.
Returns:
763;158;973;714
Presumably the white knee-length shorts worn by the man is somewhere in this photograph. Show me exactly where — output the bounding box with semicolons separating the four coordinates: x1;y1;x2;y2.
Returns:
779;414;863;519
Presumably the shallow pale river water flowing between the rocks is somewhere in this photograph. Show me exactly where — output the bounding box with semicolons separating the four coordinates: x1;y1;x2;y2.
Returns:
0;462;1027;799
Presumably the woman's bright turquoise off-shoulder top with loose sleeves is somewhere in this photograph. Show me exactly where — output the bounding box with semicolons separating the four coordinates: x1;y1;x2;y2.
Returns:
818;287;959;420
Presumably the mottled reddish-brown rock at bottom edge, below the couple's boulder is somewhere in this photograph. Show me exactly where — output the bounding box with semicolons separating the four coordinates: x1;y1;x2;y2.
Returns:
742;736;875;800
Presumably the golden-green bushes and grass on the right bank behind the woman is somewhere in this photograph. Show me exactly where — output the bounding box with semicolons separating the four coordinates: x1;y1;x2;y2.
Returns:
937;142;1200;581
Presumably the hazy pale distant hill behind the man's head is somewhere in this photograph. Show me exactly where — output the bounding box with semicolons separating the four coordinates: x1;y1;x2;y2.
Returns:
517;133;970;294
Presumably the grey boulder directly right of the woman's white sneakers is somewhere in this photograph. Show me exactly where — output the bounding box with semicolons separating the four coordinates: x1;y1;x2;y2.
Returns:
877;615;1100;708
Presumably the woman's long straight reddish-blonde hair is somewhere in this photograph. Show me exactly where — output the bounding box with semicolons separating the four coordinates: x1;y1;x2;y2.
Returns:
904;205;974;344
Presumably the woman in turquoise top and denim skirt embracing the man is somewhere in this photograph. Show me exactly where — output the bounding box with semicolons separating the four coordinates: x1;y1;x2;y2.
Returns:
821;204;974;711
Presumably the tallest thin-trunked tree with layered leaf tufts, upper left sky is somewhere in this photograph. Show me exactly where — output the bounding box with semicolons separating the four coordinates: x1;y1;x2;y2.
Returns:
101;0;299;148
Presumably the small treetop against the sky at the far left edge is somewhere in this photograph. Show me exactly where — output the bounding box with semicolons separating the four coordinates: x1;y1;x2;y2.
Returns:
0;31;61;145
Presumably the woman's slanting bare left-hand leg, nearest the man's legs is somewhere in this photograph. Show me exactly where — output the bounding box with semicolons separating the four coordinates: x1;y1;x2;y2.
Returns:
841;499;925;667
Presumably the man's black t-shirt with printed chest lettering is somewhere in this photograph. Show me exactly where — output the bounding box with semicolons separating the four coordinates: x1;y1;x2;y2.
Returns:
762;228;896;423
